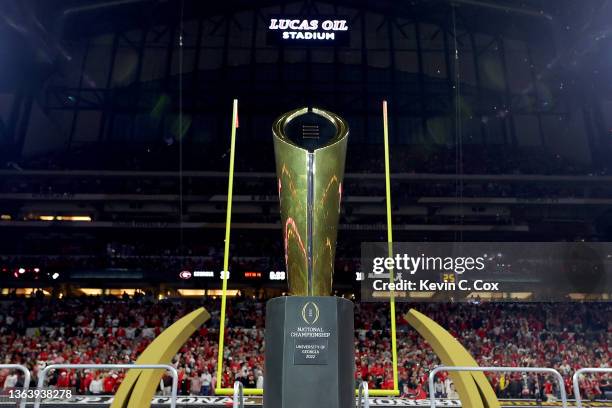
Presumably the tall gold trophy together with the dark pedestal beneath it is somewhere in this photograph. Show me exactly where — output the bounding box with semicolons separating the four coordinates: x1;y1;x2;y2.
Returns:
263;108;355;408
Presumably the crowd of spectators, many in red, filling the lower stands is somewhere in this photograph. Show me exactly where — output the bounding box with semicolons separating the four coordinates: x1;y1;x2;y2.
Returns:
0;293;612;399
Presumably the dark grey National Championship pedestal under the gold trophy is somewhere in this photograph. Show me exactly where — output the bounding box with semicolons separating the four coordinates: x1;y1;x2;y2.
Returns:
263;296;355;408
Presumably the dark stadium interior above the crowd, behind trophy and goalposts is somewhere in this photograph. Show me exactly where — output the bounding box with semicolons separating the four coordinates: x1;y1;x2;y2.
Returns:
0;0;612;293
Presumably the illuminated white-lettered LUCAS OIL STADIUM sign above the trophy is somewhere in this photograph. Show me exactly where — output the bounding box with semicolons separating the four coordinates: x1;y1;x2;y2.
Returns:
268;16;349;45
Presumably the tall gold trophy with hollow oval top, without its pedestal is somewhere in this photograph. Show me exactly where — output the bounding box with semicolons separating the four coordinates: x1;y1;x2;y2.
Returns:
272;108;349;296
